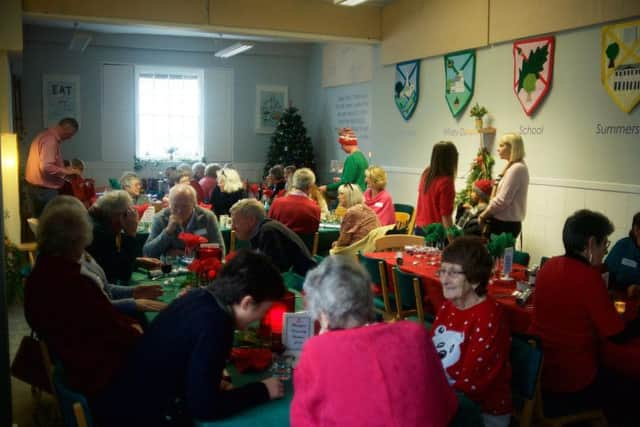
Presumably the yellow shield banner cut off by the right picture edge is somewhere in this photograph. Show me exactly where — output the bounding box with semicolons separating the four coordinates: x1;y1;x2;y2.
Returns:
600;20;640;113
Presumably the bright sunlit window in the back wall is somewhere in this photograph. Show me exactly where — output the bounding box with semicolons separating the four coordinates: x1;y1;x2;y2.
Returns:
135;67;204;160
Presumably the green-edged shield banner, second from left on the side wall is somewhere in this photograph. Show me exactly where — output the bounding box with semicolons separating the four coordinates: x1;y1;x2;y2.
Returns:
444;50;476;117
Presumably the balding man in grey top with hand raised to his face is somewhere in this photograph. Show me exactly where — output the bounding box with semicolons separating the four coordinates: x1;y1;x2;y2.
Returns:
142;184;224;257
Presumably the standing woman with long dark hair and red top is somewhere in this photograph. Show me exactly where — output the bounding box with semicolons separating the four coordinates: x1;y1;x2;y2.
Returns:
416;141;458;234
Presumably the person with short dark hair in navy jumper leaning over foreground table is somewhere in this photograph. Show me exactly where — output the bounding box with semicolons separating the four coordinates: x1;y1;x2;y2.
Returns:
92;250;285;427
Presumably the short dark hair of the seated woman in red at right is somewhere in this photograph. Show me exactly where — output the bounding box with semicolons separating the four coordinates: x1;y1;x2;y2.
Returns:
562;209;614;255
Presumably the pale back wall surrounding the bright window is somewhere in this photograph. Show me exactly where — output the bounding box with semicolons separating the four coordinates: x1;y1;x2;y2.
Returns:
16;26;309;185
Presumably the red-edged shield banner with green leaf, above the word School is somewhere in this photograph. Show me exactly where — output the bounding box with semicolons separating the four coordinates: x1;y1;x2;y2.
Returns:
513;36;555;116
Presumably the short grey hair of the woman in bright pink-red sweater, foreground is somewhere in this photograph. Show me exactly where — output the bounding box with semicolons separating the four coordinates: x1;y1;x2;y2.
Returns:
303;255;373;329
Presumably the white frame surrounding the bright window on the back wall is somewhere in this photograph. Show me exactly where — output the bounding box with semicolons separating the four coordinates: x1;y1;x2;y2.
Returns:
134;65;205;161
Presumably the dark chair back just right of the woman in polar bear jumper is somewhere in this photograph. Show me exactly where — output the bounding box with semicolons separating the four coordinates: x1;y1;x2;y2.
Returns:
511;334;543;427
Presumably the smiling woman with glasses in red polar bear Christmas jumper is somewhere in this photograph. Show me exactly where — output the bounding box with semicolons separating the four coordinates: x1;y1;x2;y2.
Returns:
431;236;511;427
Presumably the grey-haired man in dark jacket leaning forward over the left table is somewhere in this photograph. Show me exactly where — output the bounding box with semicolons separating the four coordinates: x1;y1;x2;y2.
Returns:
230;199;316;276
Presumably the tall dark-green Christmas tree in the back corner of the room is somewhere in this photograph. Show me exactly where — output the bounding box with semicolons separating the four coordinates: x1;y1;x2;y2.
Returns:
264;107;315;175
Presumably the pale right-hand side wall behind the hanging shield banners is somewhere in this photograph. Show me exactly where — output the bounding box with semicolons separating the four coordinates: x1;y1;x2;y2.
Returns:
312;26;640;263
